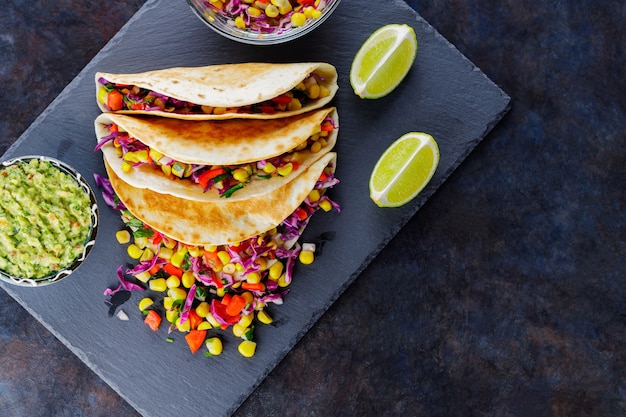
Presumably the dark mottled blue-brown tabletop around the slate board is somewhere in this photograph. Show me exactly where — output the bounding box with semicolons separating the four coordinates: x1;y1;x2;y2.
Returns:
0;0;626;417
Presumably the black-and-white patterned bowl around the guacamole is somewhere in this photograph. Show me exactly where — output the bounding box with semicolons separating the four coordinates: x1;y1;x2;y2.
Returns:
0;155;98;287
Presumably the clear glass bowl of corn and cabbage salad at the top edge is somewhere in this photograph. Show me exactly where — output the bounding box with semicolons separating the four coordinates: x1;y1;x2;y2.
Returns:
187;0;340;45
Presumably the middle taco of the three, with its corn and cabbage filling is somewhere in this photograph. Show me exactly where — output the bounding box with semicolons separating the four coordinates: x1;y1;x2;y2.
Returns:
95;108;338;202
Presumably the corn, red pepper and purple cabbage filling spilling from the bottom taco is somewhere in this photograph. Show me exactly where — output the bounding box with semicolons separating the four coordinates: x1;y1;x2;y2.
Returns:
95;167;340;357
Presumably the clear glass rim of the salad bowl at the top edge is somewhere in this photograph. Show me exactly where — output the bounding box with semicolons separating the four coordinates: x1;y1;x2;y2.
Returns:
186;0;341;46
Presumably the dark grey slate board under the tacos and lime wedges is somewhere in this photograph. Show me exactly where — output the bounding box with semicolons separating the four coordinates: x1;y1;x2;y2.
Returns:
1;0;509;416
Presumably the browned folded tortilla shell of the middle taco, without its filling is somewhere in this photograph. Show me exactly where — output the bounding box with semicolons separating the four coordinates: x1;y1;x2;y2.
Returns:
95;107;338;202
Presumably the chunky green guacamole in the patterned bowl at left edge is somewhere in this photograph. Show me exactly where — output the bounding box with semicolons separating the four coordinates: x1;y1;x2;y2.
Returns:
0;159;91;279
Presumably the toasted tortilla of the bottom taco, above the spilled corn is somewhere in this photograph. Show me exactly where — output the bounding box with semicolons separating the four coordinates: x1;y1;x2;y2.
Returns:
105;152;337;246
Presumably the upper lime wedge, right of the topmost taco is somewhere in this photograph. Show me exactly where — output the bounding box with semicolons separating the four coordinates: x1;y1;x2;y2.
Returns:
350;24;417;99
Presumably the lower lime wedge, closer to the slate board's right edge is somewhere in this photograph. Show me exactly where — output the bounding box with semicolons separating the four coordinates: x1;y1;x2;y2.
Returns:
369;132;439;207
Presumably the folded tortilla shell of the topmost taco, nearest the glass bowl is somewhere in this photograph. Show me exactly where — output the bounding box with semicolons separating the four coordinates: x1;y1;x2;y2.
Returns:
95;62;338;120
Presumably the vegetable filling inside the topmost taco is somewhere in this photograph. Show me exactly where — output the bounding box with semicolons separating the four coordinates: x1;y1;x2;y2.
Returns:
98;73;331;115
